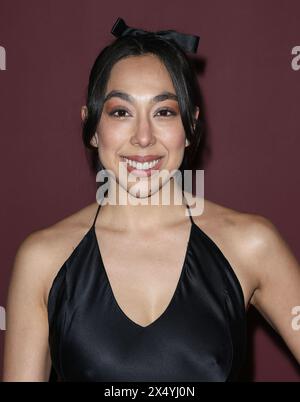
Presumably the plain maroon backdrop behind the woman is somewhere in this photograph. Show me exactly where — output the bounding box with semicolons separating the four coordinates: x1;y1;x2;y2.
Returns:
0;0;300;381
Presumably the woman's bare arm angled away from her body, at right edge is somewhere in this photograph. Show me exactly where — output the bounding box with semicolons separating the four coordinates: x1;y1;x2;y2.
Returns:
251;216;300;363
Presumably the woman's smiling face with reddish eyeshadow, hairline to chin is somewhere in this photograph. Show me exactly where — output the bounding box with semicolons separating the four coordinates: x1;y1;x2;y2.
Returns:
93;54;197;198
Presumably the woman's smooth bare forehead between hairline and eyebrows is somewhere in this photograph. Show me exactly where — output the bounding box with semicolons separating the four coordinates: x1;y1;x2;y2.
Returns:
107;54;175;93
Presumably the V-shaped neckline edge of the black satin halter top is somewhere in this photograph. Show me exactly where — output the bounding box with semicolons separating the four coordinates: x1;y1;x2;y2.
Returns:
92;216;194;330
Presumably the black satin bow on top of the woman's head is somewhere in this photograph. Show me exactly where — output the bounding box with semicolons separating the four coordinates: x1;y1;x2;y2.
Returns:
111;17;200;53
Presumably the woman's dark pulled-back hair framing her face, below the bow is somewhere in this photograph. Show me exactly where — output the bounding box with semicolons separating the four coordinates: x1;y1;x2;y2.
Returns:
82;32;203;172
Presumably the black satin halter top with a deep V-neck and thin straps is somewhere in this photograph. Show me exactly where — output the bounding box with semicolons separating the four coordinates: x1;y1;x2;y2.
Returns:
48;199;246;382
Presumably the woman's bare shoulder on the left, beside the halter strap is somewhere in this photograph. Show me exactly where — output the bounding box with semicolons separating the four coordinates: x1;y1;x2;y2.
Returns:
13;203;97;306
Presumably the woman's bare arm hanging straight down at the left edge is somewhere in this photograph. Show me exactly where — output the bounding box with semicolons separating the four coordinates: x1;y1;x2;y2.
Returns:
3;232;51;381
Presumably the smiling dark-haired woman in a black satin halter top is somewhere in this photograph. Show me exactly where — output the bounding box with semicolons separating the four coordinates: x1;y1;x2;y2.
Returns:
4;19;300;381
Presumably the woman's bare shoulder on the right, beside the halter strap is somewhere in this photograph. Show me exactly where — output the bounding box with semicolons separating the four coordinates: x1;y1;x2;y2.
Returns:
195;199;283;305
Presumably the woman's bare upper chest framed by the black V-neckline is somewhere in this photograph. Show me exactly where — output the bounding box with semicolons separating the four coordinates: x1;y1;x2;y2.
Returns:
95;223;191;326
